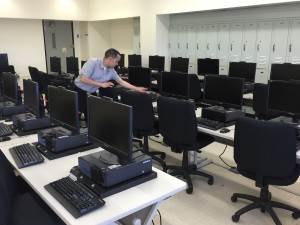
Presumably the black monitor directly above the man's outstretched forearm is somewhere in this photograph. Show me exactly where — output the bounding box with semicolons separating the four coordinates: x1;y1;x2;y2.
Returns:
128;66;151;90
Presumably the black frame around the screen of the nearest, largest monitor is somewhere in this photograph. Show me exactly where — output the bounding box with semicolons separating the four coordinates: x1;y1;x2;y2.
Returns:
88;95;133;163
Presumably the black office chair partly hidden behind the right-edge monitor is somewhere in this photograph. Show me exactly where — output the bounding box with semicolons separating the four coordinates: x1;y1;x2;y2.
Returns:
252;83;280;120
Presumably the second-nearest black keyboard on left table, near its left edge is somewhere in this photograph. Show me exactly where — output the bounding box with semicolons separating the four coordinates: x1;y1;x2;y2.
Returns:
9;144;44;168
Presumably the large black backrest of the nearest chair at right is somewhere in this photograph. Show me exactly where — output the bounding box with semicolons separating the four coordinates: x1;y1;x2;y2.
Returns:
234;117;299;179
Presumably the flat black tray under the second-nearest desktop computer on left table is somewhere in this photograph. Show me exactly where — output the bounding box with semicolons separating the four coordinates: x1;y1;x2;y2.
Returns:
32;142;99;160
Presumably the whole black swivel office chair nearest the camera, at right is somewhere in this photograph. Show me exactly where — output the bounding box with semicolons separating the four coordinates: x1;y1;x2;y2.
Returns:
231;117;300;225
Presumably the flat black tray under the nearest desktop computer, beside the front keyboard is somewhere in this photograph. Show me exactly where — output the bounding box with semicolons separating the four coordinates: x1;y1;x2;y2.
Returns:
70;166;157;198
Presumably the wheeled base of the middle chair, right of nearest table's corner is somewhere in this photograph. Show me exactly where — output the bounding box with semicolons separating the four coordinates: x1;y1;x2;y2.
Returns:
164;151;214;194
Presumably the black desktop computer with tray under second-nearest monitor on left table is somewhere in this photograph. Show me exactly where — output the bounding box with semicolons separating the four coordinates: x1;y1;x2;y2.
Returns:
33;127;98;160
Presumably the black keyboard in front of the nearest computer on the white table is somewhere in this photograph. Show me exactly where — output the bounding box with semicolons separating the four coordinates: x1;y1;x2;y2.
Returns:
45;177;105;218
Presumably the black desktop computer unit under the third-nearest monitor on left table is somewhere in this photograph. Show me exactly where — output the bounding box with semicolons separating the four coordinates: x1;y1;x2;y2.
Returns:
12;113;54;136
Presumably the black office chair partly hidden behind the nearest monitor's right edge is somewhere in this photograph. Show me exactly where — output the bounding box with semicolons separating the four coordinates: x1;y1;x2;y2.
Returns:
121;91;166;168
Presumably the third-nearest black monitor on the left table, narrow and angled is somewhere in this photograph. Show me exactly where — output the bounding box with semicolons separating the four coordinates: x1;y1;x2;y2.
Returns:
23;80;45;118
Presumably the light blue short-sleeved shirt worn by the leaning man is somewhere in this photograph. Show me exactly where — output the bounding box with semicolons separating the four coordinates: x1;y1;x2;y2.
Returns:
75;58;121;92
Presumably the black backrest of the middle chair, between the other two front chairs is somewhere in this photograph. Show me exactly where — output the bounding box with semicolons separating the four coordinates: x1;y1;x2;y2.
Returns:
157;96;197;145
